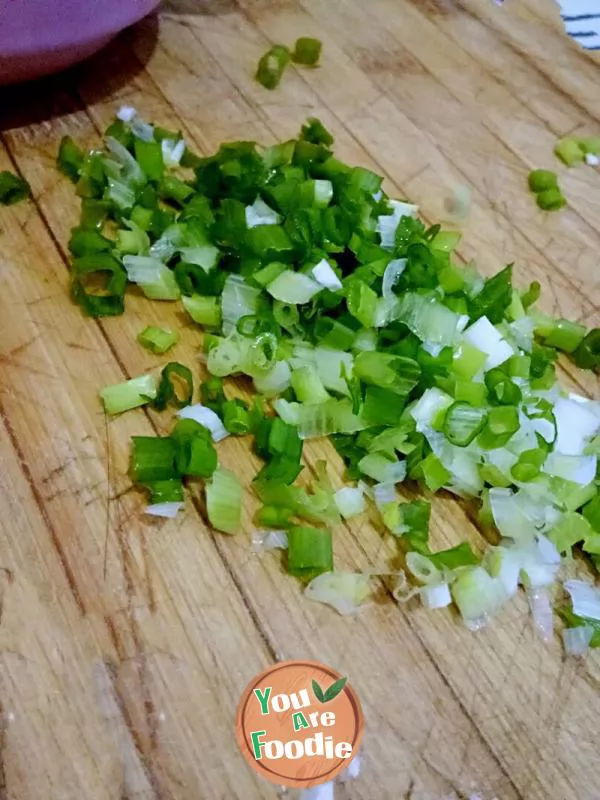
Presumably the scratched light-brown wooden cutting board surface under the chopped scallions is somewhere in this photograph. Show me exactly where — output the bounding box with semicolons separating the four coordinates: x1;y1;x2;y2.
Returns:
0;0;600;800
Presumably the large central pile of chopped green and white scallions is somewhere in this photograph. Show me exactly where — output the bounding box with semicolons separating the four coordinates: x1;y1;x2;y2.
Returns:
59;109;600;646
